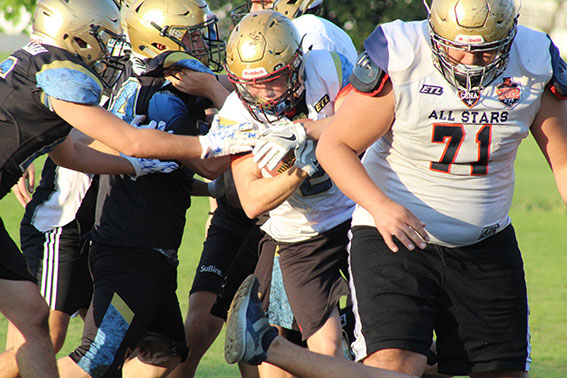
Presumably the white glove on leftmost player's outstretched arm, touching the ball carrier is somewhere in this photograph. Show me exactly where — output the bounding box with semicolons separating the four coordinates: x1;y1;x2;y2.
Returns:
199;122;258;159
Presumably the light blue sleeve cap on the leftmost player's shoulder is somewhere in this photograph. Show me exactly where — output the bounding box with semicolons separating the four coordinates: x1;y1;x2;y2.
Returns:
35;60;104;105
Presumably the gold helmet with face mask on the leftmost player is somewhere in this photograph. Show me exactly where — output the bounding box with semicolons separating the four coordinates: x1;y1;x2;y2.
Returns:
32;0;129;87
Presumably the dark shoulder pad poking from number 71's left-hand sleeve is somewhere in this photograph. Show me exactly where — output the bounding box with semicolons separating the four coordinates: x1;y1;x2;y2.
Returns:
349;50;388;96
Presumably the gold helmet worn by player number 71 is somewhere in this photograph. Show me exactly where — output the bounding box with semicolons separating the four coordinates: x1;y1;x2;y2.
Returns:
426;0;519;92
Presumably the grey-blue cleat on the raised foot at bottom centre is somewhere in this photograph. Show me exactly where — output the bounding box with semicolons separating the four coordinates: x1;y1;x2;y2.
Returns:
224;274;278;365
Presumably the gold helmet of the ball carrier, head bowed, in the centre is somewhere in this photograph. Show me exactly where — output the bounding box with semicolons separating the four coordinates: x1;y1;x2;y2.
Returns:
226;10;304;120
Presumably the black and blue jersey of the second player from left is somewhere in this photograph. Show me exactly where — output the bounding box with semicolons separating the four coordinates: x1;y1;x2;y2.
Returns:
92;53;211;249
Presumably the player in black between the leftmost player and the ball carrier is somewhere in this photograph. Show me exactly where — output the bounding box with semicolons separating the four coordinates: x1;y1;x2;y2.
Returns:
56;0;230;376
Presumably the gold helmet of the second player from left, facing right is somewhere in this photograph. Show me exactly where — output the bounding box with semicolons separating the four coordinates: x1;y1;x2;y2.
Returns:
125;0;225;71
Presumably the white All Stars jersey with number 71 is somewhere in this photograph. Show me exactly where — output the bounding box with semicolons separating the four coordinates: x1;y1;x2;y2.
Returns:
353;21;552;247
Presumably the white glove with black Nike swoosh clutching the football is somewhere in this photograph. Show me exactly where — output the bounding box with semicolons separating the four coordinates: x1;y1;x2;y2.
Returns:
252;119;307;170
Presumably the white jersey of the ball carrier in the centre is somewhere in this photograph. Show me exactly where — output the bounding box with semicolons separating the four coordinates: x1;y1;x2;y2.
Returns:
218;50;354;243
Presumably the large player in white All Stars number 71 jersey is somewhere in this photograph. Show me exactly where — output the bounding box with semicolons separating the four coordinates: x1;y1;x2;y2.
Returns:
318;0;567;377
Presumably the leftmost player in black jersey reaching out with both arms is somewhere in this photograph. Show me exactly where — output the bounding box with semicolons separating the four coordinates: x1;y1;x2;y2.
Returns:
0;0;254;377
